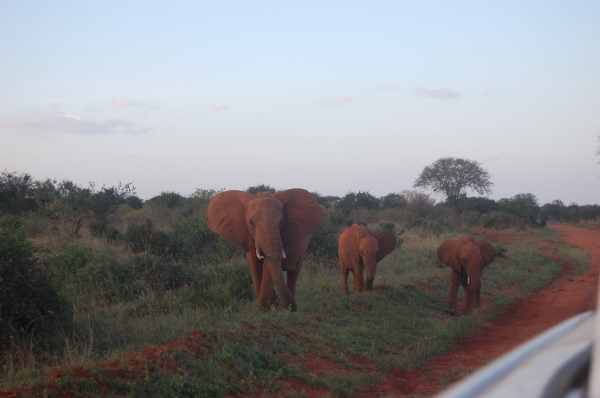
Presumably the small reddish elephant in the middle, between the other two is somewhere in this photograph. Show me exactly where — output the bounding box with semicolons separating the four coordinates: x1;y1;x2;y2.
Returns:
338;224;396;294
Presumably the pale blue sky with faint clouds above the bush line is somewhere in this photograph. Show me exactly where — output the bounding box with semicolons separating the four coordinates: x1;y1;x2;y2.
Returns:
0;0;600;205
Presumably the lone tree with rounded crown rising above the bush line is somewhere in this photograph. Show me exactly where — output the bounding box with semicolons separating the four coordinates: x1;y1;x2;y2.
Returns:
413;158;494;200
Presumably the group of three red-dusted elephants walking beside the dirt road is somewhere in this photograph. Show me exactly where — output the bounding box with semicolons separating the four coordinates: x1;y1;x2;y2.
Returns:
206;188;496;313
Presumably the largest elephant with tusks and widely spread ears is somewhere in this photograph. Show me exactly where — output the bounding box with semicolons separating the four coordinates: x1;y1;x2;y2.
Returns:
206;189;324;311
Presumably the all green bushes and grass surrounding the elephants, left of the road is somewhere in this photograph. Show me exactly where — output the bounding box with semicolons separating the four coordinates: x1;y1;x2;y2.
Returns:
0;173;589;396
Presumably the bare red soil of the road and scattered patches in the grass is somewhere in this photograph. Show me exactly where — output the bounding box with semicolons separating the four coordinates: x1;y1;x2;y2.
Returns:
0;224;600;398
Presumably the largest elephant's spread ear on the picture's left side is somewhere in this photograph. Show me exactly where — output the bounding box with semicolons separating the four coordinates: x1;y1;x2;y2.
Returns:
206;191;256;251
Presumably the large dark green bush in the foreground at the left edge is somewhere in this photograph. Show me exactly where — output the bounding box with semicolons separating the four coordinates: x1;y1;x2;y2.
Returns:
0;217;72;349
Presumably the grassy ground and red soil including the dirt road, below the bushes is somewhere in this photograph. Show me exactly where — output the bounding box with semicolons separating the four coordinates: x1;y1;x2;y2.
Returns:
0;224;600;397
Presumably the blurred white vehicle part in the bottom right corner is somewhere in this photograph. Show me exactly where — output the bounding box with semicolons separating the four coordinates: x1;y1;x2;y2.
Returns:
437;307;600;398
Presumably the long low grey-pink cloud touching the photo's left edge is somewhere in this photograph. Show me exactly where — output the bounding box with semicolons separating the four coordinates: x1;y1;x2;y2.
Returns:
0;110;151;135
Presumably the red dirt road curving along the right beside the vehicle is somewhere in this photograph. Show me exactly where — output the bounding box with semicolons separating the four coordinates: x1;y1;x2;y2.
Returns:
365;224;600;397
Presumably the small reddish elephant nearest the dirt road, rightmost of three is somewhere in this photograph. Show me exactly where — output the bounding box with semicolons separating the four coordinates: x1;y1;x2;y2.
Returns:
437;235;496;314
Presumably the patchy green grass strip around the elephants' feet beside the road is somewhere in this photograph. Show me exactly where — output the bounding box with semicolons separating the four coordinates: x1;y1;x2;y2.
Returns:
0;225;590;397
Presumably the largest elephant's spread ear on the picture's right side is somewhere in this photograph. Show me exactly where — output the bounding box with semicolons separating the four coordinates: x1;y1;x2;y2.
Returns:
272;188;323;246
